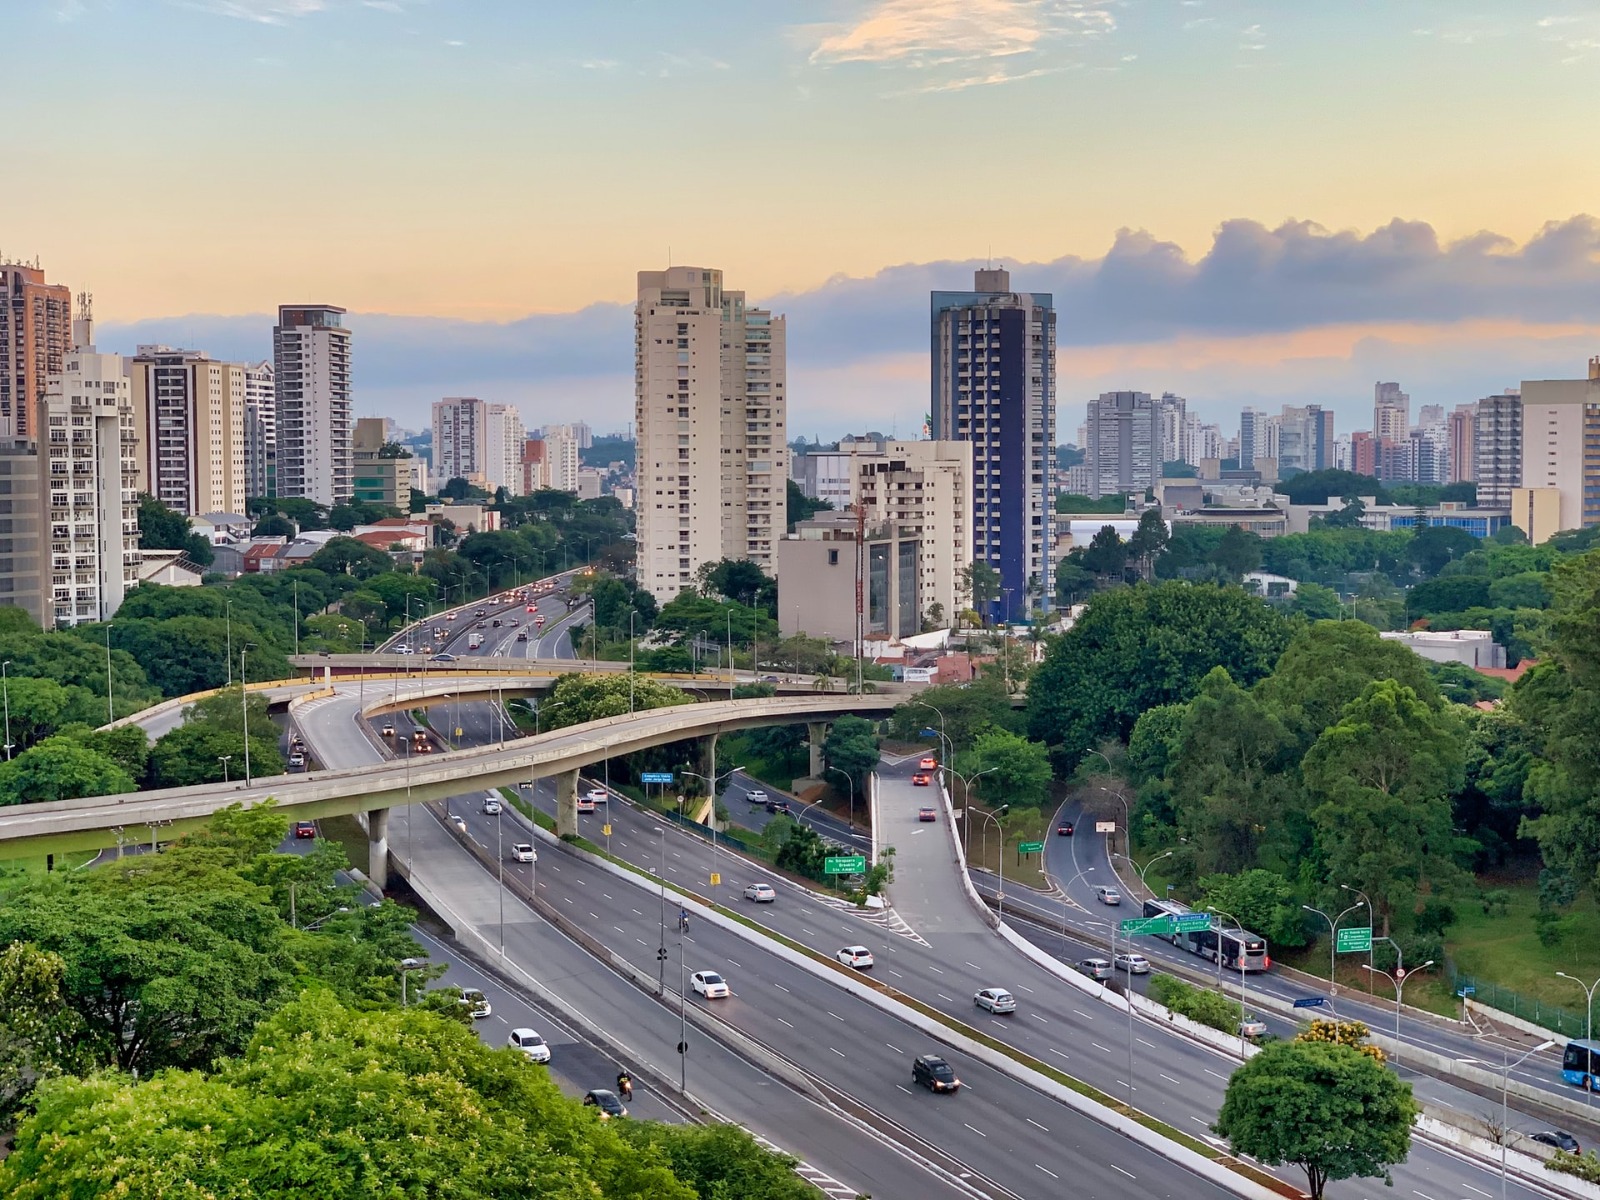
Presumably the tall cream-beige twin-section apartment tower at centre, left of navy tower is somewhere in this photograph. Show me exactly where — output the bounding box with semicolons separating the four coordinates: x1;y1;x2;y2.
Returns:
636;267;789;603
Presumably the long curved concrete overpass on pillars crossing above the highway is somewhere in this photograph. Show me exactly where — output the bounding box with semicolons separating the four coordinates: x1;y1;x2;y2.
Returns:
0;678;904;886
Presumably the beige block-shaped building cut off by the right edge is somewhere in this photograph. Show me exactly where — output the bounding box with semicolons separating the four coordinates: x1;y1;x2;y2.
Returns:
1512;357;1600;541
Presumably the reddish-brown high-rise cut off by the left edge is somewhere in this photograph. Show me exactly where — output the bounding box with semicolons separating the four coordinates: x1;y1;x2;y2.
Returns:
0;261;72;438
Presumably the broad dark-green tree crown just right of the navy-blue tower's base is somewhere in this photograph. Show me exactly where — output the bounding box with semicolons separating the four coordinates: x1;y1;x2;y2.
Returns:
1027;582;1291;766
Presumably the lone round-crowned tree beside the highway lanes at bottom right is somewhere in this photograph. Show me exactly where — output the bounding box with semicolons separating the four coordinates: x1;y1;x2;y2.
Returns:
1211;1042;1419;1200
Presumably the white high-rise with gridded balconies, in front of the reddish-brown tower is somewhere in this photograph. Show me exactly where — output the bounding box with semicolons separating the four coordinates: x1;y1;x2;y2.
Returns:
38;296;139;626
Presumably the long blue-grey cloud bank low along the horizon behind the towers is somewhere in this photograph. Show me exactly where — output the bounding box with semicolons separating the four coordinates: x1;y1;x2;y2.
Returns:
98;216;1600;435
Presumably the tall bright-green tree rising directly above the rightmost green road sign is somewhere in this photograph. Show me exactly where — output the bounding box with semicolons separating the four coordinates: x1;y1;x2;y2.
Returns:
1302;678;1464;934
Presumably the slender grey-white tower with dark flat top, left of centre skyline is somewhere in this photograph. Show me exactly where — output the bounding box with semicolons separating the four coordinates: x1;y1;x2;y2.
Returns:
272;304;355;507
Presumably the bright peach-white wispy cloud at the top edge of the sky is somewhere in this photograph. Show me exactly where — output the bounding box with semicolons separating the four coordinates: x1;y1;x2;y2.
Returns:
811;0;1115;69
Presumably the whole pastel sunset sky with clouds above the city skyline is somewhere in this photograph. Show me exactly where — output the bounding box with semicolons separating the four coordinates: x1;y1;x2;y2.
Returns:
12;0;1600;440
